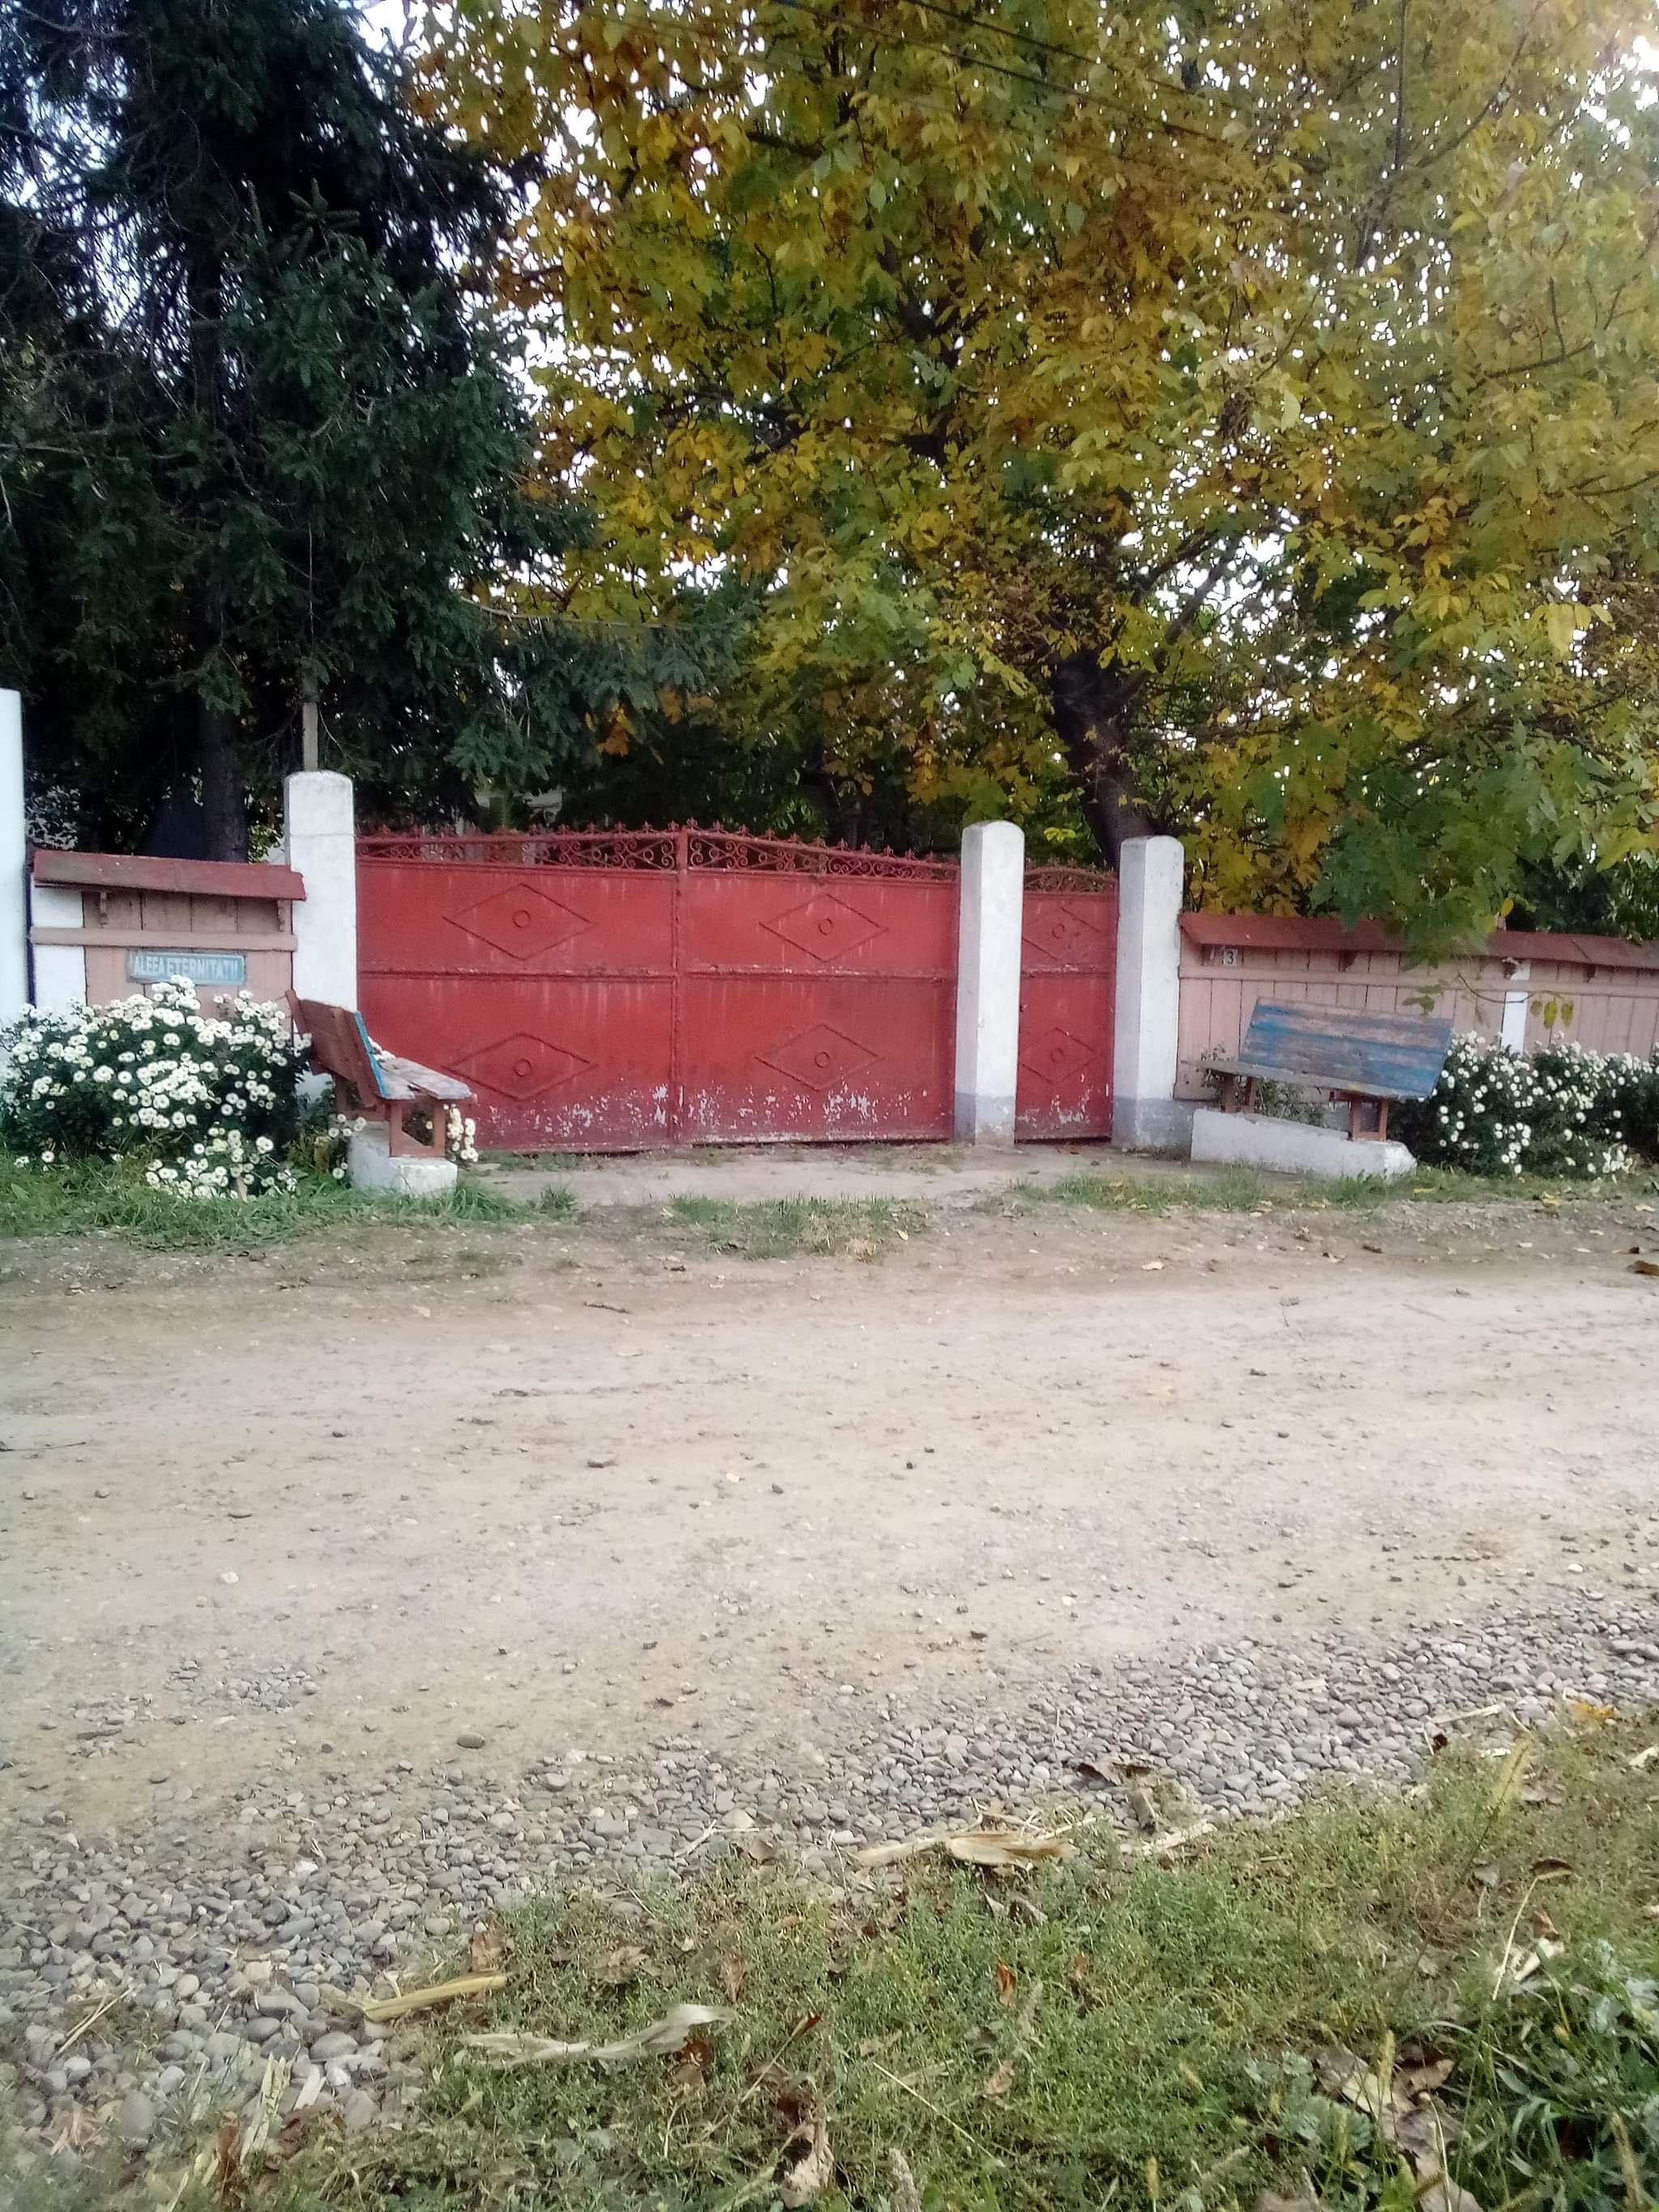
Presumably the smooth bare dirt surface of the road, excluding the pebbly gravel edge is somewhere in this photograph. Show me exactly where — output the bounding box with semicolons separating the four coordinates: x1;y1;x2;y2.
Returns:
0;1199;1659;1822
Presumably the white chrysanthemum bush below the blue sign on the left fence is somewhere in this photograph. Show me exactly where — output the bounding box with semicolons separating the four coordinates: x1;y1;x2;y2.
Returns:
0;975;305;1199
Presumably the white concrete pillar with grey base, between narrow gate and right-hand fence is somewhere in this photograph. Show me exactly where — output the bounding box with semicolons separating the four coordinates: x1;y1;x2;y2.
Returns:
1113;836;1192;1150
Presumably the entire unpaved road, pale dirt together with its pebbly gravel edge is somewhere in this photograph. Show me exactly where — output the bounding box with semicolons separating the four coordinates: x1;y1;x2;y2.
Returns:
0;1199;1659;2157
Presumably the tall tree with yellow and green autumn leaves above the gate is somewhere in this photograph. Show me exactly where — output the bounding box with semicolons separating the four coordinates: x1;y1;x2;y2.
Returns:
427;0;1659;931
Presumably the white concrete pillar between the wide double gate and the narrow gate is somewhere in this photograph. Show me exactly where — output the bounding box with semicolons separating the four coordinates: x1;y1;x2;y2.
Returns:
956;823;1026;1144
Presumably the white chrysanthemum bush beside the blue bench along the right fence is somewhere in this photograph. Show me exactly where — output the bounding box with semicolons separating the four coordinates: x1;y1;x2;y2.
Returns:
1393;1033;1659;1177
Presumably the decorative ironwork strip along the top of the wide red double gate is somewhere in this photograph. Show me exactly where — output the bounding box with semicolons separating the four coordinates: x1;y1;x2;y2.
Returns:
356;823;957;883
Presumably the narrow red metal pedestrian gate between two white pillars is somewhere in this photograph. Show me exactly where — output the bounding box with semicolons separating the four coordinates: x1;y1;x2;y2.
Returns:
1013;867;1117;1137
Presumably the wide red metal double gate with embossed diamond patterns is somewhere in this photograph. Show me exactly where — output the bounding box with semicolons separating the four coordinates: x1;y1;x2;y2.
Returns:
358;829;957;1153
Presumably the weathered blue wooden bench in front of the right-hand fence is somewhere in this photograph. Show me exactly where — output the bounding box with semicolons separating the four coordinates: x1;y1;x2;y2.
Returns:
1205;1004;1451;1141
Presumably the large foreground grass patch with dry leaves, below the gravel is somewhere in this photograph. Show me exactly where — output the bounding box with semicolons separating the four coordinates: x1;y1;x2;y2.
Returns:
207;1728;1659;2212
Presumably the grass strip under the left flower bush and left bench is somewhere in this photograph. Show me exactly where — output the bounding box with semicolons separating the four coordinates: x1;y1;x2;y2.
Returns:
0;1157;524;1252
